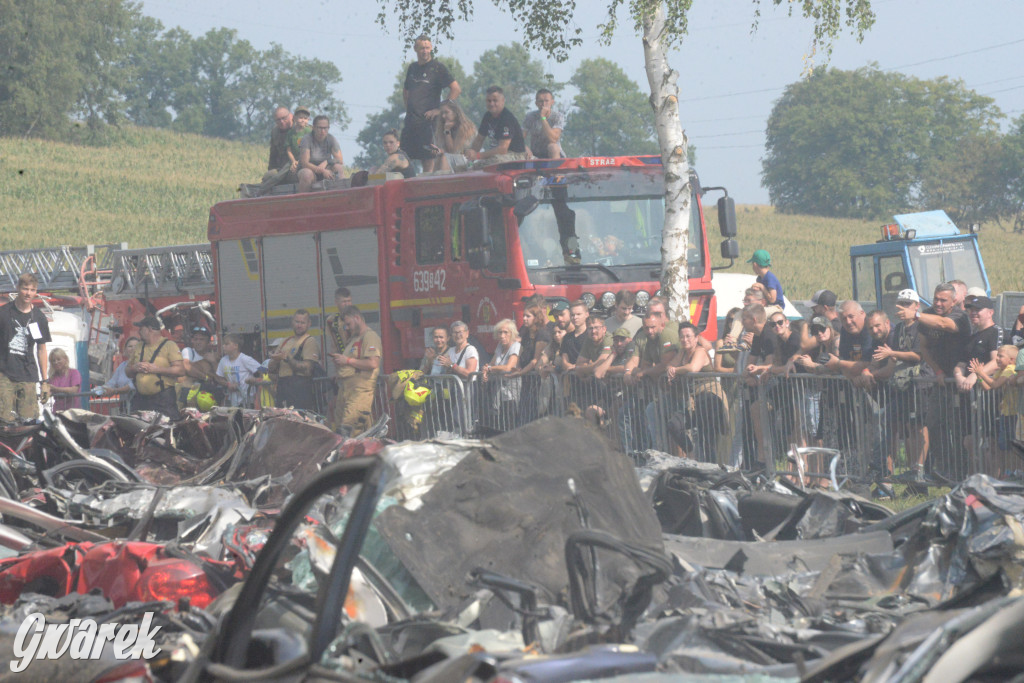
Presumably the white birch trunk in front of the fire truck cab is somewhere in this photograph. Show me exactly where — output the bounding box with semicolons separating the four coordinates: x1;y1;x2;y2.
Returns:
643;2;691;321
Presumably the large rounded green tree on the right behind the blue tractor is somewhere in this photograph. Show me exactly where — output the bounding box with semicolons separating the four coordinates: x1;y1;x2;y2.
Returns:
762;68;1000;218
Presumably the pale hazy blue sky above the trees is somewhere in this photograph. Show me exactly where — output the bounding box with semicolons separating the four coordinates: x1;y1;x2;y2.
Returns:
142;0;1024;204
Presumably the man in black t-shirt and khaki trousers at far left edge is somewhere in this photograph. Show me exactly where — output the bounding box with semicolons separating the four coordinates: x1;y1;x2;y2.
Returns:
0;272;50;423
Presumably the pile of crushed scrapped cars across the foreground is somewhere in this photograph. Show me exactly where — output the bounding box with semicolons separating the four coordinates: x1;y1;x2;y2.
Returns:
0;410;1024;682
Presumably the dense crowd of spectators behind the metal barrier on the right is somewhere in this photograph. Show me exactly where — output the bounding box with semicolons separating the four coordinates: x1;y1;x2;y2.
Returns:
403;245;1024;480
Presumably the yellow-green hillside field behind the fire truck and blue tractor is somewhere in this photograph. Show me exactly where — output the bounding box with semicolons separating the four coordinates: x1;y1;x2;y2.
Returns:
0;127;1024;299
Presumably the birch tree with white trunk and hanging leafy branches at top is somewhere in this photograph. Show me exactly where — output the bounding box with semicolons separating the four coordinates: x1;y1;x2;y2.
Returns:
377;0;874;319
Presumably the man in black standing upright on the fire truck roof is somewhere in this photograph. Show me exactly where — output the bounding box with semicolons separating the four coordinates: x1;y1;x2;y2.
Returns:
399;36;462;173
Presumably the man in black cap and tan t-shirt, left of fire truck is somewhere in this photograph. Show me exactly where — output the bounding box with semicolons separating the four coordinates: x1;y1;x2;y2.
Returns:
125;315;185;420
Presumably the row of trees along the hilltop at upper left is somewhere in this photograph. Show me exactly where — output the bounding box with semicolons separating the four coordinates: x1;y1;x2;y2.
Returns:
0;0;348;140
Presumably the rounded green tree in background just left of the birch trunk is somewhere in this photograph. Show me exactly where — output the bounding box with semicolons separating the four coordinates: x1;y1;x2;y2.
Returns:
563;57;658;157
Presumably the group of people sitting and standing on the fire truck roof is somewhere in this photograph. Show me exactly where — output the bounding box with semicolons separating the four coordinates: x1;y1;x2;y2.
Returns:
251;36;565;194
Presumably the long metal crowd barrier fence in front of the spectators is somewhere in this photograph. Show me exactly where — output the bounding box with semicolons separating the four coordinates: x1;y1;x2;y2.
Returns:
374;373;1024;482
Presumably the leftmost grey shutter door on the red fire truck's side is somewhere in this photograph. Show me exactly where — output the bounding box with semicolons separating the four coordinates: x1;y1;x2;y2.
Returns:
217;239;263;334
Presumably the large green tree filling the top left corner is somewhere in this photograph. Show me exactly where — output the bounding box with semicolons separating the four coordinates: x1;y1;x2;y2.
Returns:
0;0;137;137
